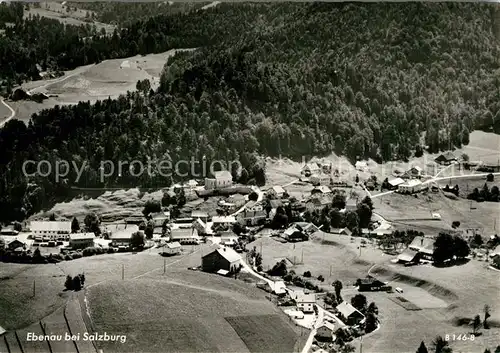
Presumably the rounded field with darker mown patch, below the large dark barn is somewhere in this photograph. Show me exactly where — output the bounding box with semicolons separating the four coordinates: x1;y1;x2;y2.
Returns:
87;266;304;352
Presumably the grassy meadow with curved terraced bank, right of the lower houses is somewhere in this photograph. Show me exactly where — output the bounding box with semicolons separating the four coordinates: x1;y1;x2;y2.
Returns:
251;230;500;353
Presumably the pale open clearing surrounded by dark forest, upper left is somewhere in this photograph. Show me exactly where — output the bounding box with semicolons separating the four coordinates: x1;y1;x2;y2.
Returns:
9;49;191;122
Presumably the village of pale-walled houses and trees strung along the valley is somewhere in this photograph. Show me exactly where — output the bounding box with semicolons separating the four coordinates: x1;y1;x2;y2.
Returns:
0;152;500;353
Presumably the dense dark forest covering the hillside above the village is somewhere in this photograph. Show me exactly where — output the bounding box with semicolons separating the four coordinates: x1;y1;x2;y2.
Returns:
0;3;500;219
